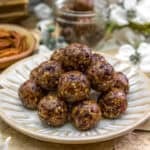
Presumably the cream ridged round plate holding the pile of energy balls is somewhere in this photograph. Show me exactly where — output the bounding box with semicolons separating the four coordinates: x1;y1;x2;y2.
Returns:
0;53;150;144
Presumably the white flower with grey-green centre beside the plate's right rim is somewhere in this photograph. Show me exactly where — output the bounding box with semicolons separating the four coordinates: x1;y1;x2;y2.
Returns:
116;43;150;73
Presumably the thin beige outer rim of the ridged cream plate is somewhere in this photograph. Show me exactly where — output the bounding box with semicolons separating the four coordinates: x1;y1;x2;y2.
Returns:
0;51;150;144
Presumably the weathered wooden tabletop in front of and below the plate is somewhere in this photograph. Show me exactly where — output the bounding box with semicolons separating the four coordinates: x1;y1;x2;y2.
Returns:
0;119;150;150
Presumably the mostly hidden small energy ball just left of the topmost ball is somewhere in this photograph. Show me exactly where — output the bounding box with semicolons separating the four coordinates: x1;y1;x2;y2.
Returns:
50;48;64;63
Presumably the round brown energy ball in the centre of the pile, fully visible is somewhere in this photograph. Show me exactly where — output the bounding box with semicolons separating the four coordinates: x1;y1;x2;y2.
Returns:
58;71;90;102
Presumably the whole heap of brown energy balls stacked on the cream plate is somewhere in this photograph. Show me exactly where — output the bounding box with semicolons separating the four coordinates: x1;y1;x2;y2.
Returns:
18;43;129;131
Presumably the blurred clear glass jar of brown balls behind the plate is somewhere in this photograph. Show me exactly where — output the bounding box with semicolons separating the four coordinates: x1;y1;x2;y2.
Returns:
54;0;107;47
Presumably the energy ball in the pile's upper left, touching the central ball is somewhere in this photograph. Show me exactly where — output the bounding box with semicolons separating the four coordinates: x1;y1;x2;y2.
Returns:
30;61;63;90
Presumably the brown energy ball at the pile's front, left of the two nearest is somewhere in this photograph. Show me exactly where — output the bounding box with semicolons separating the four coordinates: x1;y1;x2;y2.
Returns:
38;94;67;126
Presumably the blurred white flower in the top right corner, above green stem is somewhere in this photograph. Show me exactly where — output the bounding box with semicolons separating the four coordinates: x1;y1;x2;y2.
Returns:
109;0;150;26
